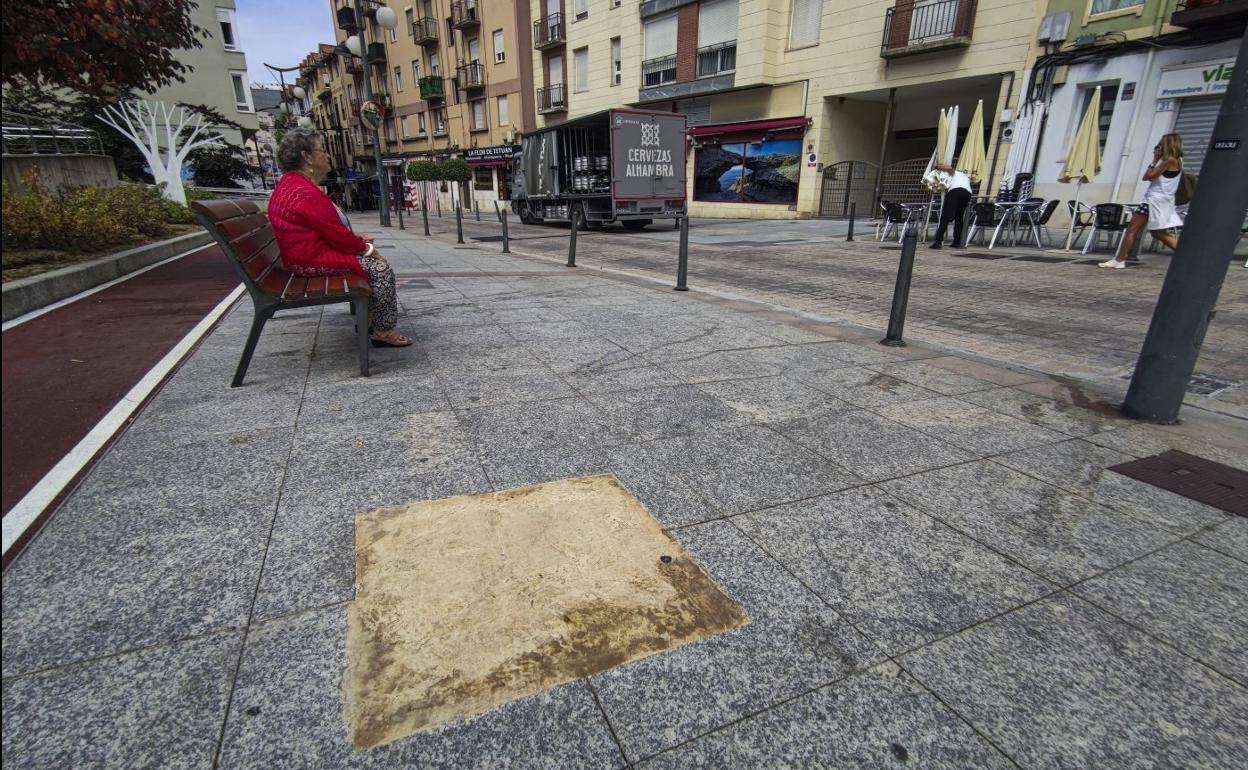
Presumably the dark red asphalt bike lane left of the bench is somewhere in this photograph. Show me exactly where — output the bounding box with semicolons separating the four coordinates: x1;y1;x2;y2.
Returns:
0;246;238;563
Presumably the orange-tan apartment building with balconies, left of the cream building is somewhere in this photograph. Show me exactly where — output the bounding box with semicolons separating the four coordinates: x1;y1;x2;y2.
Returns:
313;0;535;207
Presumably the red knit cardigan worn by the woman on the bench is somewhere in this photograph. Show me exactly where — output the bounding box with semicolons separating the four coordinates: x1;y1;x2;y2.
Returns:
268;171;368;278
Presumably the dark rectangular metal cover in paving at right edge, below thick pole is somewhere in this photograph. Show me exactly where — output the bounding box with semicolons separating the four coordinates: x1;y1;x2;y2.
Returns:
1109;449;1248;517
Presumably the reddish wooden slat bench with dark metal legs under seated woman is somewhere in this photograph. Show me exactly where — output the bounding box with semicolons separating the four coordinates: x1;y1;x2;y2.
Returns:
191;198;373;388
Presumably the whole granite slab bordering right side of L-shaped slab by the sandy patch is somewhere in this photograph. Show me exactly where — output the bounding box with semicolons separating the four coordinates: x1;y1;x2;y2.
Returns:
734;488;1055;655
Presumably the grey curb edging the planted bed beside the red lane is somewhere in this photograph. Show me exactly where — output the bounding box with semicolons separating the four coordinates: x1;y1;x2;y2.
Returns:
2;231;212;321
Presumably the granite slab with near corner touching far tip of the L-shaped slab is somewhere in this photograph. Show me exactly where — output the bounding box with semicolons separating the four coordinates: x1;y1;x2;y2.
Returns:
653;427;862;514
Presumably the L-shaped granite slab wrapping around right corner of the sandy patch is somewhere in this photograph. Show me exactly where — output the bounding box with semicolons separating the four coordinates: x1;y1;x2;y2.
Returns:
592;522;882;761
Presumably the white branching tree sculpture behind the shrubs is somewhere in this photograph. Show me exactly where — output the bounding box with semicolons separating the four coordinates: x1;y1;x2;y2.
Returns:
96;99;222;206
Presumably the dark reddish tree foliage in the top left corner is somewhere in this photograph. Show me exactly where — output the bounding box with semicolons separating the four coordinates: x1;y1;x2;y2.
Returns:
2;0;206;101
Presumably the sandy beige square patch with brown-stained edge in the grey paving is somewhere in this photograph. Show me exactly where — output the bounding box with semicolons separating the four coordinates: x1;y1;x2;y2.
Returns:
346;474;749;749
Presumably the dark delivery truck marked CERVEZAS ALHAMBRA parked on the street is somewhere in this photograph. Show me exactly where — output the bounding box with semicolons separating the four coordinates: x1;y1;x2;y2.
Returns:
512;110;688;230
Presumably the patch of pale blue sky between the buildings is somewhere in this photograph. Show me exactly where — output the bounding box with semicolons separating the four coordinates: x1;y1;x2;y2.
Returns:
235;0;334;82
